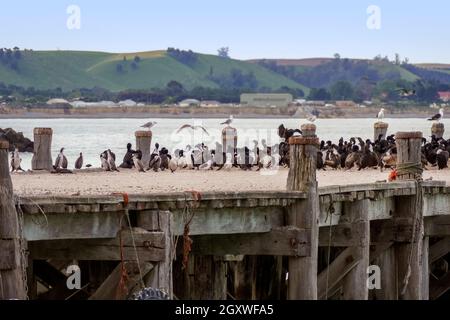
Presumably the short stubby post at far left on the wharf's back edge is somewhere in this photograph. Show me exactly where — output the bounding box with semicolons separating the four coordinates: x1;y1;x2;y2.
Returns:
31;128;53;171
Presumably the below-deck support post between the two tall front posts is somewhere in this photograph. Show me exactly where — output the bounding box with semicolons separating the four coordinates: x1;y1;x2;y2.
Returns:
342;199;370;300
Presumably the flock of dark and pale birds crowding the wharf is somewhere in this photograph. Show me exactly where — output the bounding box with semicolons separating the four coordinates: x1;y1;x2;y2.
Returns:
7;108;450;173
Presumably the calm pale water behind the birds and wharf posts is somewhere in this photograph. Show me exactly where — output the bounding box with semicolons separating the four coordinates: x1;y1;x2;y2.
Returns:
0;118;450;169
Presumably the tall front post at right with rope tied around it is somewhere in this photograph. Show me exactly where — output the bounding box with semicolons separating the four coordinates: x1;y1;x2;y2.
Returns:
394;132;428;300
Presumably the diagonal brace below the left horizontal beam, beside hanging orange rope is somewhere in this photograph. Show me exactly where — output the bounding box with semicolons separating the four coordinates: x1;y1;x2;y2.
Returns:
89;261;154;300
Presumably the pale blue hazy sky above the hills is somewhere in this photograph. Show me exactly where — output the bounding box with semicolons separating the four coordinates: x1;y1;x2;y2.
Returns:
0;0;450;63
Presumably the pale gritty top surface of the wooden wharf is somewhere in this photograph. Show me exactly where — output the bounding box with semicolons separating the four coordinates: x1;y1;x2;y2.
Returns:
12;168;450;196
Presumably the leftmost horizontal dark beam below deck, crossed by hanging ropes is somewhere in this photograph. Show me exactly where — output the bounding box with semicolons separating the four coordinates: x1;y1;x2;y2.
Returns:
29;232;166;261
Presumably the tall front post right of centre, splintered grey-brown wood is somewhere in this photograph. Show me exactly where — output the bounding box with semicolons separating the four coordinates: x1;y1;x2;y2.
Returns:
287;124;319;300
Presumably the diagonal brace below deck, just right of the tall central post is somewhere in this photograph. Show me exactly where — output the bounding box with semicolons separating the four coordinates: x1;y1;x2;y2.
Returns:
317;247;361;299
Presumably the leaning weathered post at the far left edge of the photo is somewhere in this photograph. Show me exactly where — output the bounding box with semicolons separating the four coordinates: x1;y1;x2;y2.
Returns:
0;140;27;300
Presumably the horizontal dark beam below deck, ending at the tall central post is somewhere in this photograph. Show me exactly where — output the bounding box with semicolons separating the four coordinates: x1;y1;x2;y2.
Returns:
192;227;310;257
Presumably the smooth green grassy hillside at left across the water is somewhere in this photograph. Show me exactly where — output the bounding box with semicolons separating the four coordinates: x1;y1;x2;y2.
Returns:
0;51;308;93
